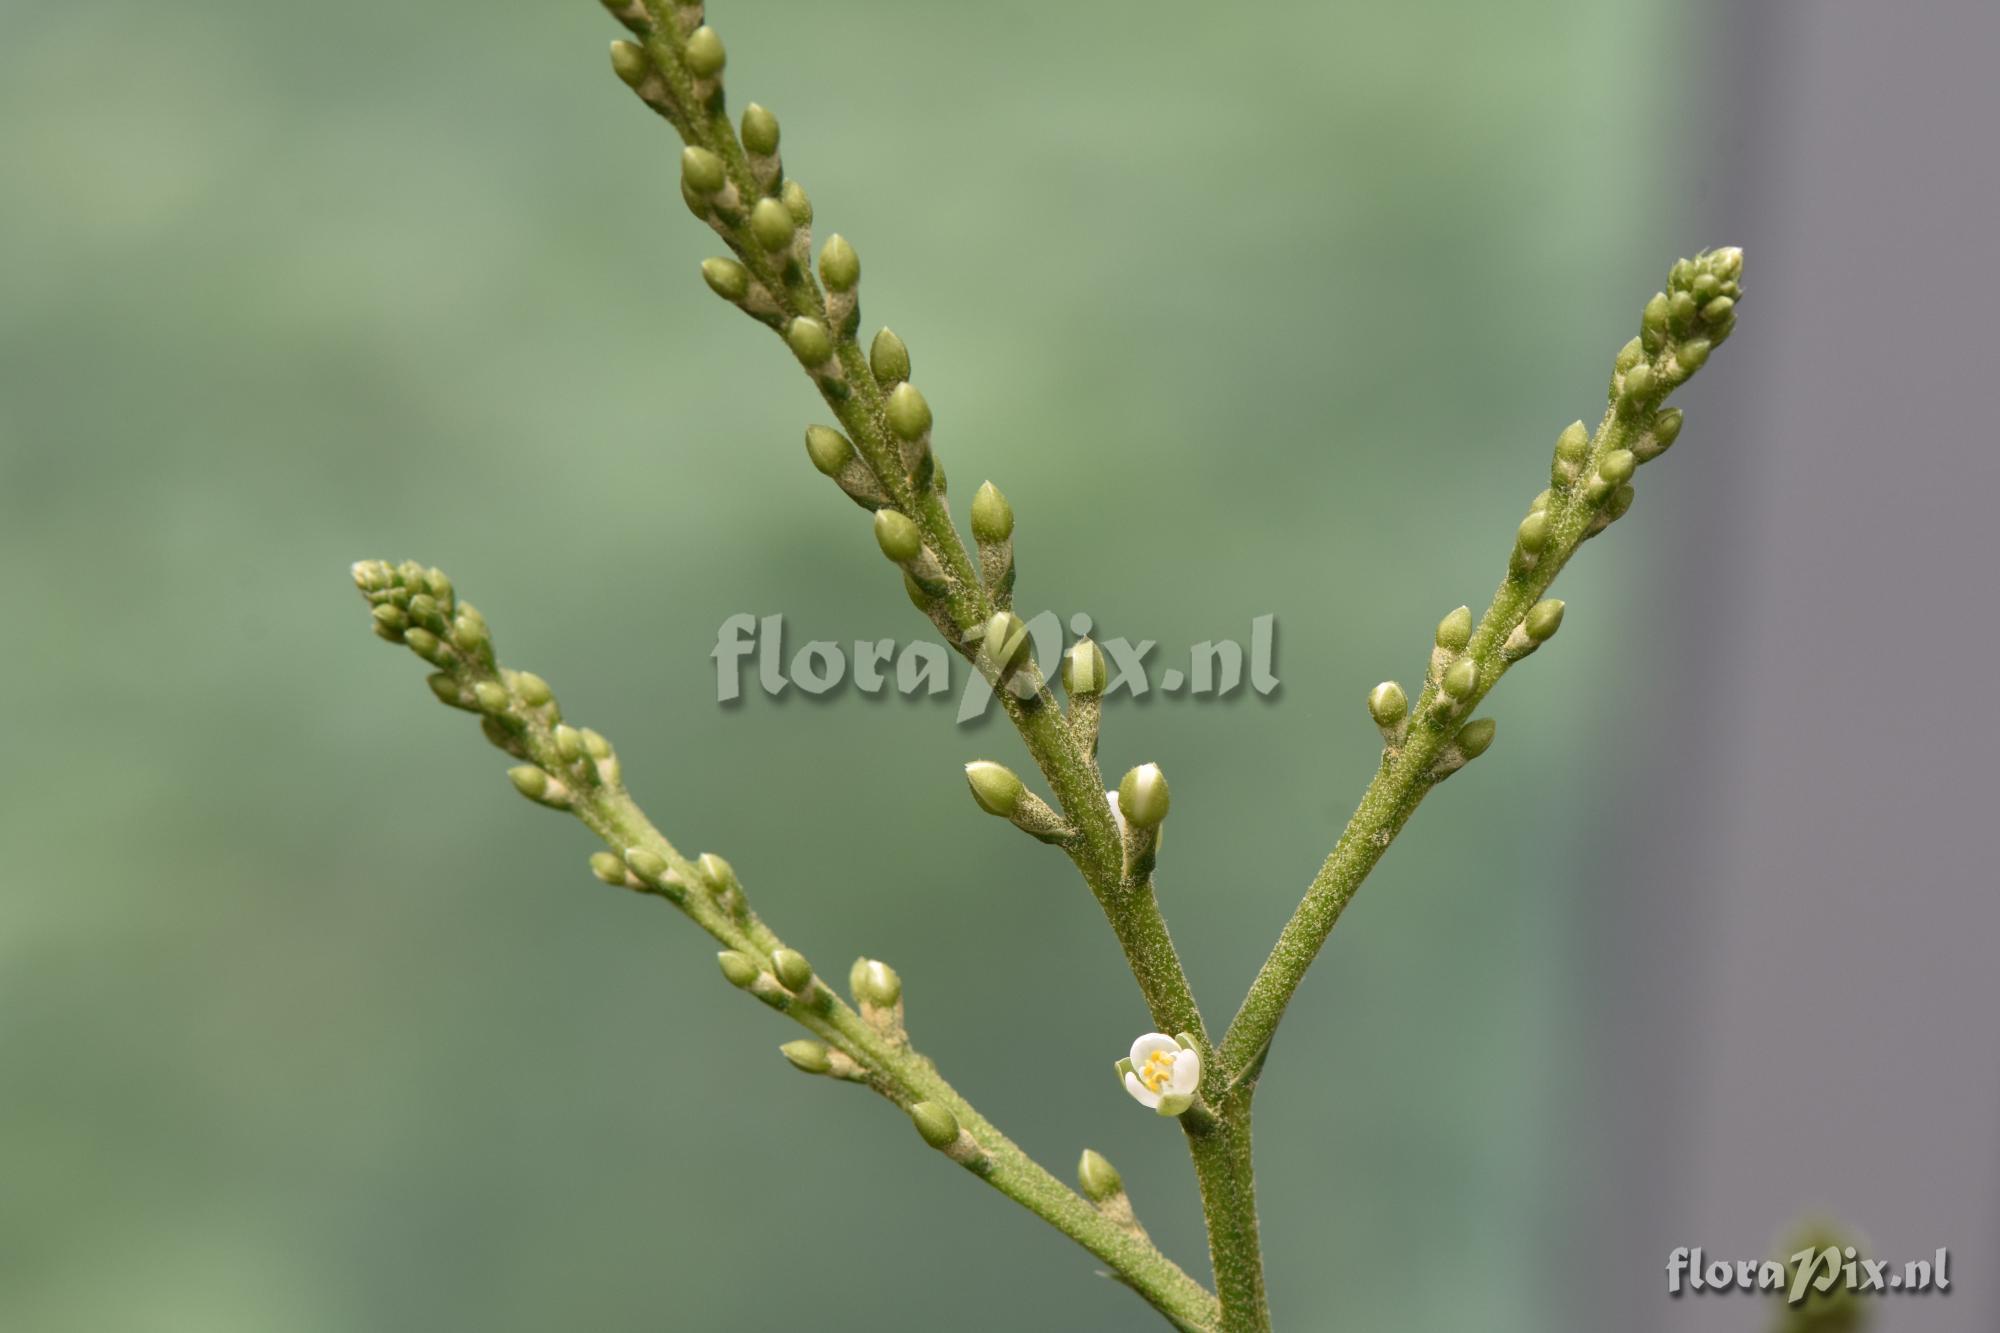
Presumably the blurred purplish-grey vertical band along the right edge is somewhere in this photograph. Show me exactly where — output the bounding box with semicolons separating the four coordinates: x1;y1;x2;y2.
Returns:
1578;0;2000;1333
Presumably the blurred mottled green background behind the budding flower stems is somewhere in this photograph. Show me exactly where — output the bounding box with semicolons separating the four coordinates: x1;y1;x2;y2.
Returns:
0;0;1712;1333
